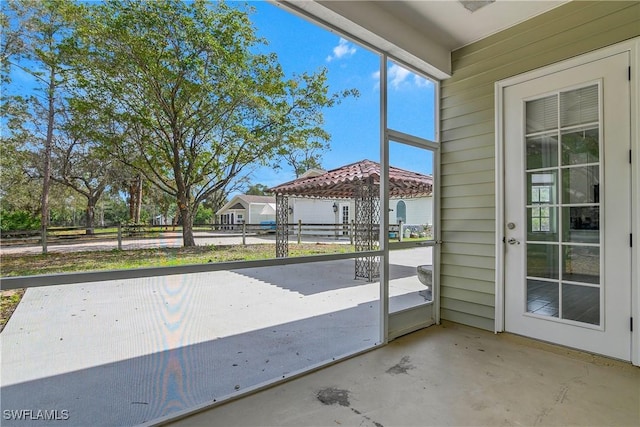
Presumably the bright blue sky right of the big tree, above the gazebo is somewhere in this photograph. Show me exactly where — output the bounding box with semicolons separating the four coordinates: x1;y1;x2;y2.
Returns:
242;1;435;186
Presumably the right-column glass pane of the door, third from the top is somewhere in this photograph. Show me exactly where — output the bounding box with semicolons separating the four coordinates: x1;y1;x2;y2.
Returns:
562;166;600;204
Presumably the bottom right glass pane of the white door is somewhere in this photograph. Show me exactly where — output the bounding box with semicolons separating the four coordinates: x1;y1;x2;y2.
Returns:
562;284;600;325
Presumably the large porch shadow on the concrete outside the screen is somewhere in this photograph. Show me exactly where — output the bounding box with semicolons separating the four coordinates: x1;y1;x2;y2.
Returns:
0;301;380;427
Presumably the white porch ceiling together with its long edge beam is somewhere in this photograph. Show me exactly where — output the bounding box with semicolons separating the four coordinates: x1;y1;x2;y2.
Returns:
272;0;568;79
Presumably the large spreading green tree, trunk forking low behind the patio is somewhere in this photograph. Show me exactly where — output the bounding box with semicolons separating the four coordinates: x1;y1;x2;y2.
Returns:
76;0;355;246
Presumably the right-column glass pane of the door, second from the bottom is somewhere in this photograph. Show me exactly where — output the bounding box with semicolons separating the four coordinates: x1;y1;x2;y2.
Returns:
562;246;600;284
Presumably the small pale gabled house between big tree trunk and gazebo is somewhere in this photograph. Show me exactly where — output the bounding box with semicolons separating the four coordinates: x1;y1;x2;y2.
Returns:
216;194;276;225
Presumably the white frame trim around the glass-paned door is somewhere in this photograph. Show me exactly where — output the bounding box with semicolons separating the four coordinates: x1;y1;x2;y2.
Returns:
494;37;640;366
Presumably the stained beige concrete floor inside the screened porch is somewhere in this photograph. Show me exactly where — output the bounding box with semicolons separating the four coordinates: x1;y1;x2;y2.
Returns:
168;323;640;427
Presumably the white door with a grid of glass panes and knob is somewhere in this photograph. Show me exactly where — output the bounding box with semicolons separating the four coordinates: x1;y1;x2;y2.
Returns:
503;53;631;360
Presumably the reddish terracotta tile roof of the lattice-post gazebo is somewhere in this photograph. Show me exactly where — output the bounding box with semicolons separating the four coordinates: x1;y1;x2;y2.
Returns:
269;159;433;198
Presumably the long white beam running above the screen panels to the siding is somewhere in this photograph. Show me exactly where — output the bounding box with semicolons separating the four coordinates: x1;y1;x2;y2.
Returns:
272;0;451;80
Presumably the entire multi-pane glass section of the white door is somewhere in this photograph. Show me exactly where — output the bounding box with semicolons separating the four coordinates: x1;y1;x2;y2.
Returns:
524;84;602;325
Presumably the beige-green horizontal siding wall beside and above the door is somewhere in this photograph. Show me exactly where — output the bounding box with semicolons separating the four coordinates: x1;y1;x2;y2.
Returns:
440;1;640;330
